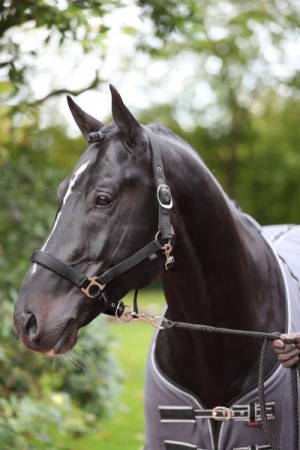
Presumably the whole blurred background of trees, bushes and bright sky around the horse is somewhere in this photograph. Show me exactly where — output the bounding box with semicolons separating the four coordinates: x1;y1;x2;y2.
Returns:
0;0;300;450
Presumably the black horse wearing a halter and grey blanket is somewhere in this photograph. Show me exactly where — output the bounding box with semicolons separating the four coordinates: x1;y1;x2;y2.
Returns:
15;87;300;450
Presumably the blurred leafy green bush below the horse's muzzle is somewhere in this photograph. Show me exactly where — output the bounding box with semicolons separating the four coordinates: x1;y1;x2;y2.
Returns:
0;302;121;450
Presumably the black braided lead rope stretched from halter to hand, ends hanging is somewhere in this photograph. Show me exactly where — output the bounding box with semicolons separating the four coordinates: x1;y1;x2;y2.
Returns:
162;320;299;450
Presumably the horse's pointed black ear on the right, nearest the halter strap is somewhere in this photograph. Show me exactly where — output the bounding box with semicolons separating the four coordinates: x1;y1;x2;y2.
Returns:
109;84;147;150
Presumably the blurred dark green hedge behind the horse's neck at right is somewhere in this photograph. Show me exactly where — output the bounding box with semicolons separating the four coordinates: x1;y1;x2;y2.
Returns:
140;94;300;225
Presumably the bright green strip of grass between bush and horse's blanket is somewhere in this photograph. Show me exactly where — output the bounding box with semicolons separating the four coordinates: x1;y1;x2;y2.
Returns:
65;290;164;450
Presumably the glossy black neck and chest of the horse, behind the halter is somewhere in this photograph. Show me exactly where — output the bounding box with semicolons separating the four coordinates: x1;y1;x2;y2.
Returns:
157;156;284;406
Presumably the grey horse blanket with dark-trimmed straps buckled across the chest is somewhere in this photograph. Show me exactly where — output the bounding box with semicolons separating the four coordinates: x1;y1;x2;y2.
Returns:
144;225;300;450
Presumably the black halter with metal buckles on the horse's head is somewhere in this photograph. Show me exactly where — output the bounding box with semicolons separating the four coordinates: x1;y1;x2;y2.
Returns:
31;125;174;316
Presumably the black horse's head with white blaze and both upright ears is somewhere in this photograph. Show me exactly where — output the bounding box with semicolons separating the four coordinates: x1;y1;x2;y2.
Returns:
15;86;173;355
